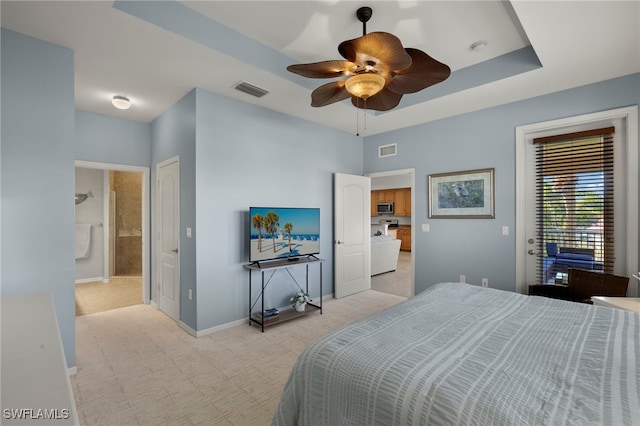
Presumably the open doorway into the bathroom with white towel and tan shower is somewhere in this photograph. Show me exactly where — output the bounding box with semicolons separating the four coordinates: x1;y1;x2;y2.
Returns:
75;161;149;315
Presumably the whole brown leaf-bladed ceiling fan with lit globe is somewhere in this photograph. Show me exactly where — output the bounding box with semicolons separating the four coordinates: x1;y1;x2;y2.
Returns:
287;7;451;111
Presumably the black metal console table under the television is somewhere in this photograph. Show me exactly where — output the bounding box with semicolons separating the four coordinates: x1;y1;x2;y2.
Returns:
244;257;324;332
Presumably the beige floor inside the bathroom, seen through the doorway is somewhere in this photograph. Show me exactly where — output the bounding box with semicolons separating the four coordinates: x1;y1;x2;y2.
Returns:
76;276;142;316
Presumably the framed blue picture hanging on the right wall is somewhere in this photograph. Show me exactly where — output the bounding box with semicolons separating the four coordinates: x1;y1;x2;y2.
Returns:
428;168;495;219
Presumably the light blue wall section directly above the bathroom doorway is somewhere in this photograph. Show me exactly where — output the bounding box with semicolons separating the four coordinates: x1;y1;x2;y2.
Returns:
74;110;151;167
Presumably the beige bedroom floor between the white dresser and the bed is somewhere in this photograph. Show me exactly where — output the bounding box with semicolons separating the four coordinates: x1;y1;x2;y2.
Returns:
71;290;405;426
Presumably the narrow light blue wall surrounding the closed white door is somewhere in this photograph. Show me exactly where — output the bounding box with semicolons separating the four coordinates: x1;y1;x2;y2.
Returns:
151;89;197;330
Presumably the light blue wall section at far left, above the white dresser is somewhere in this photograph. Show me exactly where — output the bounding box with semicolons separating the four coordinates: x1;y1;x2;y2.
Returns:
1;29;75;366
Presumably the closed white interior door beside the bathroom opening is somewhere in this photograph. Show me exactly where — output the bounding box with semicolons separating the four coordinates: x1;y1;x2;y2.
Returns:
157;159;180;321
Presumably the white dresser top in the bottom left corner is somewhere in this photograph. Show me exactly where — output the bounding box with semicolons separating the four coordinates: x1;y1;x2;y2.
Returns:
0;293;79;425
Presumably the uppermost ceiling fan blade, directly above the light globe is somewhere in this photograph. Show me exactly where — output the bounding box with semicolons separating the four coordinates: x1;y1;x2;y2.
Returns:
338;32;411;76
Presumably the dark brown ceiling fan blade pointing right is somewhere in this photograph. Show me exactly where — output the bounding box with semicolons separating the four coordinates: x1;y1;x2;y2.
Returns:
386;48;451;94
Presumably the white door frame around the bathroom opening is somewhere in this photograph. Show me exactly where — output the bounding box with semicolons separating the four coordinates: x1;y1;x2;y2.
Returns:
75;160;151;305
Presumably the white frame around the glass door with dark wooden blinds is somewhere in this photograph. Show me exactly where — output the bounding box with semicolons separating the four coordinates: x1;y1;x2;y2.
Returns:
515;105;639;297
